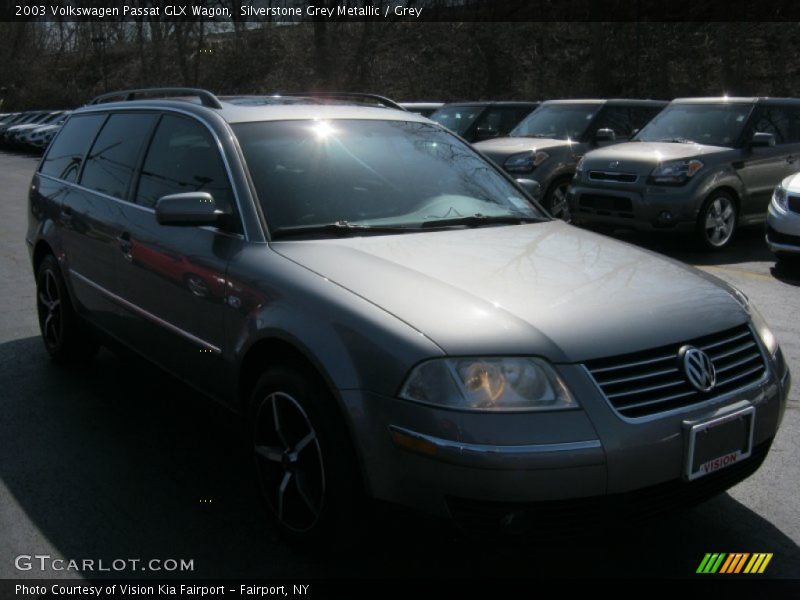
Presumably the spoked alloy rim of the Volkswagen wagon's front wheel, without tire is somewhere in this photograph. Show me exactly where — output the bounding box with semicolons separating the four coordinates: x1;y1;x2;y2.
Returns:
254;392;325;532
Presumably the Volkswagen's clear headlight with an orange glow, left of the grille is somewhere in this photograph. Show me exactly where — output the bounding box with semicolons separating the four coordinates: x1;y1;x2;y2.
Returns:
400;358;578;411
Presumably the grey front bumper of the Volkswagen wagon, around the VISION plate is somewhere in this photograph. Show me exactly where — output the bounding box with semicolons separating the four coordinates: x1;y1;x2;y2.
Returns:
341;346;790;521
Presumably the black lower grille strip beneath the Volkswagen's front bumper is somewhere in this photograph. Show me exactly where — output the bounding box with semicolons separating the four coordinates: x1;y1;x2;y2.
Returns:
447;439;772;537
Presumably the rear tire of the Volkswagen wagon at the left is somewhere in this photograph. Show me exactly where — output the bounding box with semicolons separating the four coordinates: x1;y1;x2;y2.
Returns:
36;254;100;364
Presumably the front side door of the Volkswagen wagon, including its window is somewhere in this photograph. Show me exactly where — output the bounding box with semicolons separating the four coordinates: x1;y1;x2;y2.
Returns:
111;114;244;395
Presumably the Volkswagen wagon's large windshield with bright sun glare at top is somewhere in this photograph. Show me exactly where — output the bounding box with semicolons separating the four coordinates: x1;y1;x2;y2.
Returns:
233;120;545;233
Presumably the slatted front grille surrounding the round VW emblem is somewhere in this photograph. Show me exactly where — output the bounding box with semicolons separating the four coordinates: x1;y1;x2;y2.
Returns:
586;324;766;418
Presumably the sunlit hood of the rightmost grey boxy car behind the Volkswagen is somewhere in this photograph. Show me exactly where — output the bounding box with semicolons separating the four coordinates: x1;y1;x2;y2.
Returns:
583;142;733;174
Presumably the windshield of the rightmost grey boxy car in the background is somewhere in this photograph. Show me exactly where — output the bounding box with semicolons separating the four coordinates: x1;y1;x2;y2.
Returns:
634;103;753;146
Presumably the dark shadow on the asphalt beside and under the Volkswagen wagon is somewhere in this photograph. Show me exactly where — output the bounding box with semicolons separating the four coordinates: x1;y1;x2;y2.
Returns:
0;337;800;578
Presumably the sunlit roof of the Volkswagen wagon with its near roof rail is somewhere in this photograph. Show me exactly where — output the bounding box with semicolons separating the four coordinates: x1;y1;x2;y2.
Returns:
73;96;430;124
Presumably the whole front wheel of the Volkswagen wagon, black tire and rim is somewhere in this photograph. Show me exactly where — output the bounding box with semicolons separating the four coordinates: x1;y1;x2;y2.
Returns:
248;365;365;551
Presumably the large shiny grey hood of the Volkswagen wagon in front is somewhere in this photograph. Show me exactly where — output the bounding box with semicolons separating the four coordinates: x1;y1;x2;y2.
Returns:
272;221;747;362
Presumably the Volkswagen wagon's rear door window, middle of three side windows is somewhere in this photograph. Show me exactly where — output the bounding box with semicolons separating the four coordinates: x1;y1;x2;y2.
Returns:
80;113;156;200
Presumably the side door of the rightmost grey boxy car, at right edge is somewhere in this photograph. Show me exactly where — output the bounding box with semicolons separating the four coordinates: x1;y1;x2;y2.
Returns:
737;105;798;222
